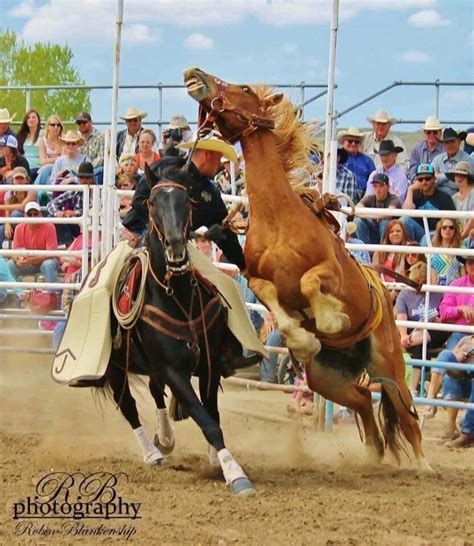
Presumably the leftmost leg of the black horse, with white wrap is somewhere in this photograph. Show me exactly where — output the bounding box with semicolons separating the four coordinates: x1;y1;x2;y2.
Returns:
108;365;163;465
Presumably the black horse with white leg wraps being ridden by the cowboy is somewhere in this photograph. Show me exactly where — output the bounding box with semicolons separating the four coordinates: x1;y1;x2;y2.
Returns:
106;168;255;495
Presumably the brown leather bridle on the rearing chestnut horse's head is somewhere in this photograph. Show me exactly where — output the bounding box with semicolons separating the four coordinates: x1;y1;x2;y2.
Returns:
198;78;275;144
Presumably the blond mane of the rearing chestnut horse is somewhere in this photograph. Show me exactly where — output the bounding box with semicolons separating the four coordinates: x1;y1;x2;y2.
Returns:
252;85;320;186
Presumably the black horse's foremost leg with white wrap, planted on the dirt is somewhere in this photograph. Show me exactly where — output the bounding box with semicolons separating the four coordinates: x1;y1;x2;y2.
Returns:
165;367;255;496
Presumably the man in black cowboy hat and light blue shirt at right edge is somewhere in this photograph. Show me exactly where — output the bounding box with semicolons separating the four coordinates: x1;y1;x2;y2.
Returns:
431;127;474;196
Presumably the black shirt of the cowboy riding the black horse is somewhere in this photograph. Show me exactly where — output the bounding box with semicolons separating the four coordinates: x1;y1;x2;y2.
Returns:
122;156;246;270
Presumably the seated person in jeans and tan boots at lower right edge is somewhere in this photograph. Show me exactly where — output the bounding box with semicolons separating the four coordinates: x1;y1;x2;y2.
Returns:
437;335;474;443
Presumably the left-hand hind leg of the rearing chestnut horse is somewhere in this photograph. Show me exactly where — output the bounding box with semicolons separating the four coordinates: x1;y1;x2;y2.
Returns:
306;362;384;462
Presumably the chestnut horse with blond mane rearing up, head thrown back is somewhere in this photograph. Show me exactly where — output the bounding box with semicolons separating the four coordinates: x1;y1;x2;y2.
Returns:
184;68;431;471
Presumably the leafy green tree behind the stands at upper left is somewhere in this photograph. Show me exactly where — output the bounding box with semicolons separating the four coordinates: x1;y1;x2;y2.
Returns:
0;31;91;127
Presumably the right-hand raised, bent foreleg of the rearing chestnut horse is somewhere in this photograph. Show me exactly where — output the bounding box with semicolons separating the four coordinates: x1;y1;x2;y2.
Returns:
300;262;351;334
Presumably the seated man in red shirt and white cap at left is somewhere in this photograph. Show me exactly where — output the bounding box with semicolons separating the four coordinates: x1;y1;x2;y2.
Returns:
8;201;59;283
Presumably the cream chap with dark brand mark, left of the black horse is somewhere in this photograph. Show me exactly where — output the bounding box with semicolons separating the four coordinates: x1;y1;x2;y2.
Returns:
51;241;132;386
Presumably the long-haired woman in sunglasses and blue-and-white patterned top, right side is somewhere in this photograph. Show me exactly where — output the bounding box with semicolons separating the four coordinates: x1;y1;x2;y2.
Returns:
431;218;463;286
